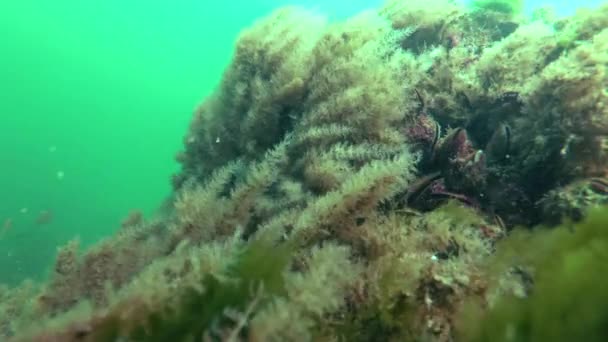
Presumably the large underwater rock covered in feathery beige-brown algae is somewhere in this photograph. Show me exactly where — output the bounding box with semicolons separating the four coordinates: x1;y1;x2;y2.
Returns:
0;0;608;341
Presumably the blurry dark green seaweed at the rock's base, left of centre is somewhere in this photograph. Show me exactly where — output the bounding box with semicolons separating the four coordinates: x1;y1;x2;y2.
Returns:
16;240;293;342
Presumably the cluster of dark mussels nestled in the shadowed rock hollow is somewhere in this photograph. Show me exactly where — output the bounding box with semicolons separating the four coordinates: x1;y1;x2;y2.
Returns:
404;92;608;228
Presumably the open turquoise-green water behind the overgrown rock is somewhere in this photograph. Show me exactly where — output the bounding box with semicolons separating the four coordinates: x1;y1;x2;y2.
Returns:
0;0;601;283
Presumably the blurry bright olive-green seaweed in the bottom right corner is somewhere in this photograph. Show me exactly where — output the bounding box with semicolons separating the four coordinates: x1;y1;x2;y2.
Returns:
462;207;608;341
